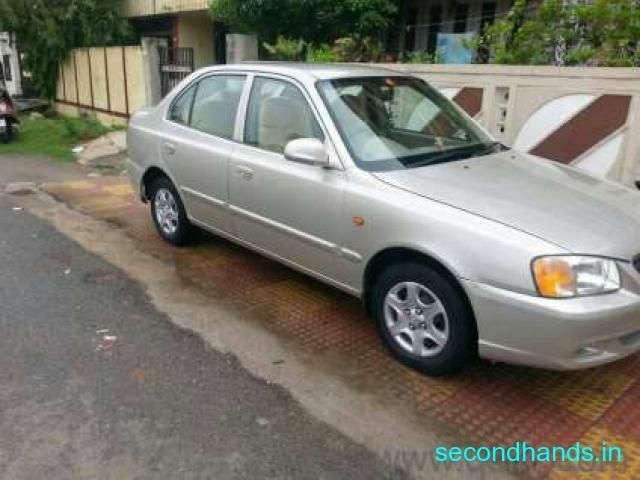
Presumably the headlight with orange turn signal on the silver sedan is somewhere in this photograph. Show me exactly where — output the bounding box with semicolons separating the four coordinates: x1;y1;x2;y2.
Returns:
532;255;620;298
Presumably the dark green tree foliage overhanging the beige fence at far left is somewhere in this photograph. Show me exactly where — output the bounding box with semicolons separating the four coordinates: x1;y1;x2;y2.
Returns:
0;0;131;98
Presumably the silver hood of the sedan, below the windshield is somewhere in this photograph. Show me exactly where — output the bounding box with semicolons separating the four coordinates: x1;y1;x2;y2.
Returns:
374;151;640;260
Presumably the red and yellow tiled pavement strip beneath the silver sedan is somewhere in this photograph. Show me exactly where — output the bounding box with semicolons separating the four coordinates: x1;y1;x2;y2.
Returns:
47;178;640;478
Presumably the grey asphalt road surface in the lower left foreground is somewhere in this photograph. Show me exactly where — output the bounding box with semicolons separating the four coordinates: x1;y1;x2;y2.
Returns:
0;194;402;480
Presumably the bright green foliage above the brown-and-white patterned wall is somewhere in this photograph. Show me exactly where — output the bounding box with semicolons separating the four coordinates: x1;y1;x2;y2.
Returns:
477;0;640;66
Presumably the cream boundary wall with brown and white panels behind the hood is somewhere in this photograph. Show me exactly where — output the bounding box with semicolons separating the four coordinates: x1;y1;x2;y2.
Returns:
388;64;640;186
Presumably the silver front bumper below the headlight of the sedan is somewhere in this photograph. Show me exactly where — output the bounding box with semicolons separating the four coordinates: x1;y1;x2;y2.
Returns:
463;281;640;370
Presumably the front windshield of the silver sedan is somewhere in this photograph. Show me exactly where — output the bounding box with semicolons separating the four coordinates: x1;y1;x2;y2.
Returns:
318;76;505;171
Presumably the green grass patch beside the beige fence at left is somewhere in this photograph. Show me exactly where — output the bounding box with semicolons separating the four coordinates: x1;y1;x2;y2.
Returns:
0;115;113;162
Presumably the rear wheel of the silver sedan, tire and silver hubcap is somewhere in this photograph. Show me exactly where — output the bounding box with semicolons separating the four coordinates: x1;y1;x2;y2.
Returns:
150;177;195;247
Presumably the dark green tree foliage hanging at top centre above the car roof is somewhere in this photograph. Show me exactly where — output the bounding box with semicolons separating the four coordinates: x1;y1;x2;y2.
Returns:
210;0;398;44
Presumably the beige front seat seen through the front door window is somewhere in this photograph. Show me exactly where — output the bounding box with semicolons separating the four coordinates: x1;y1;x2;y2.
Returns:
257;97;317;152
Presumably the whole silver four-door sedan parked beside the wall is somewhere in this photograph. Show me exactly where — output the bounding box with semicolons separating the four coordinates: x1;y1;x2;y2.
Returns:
128;64;640;375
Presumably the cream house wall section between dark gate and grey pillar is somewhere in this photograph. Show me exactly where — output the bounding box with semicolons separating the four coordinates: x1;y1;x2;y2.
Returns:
177;12;215;68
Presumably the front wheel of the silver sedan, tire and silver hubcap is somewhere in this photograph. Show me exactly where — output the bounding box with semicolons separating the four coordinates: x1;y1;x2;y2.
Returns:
370;262;477;376
